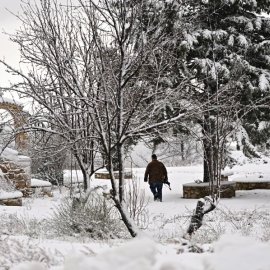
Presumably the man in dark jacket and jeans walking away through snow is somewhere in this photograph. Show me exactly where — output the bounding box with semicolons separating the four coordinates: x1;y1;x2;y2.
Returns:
144;154;168;202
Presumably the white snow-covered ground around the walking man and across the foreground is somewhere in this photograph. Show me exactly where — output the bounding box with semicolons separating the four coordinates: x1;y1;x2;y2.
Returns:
0;151;270;270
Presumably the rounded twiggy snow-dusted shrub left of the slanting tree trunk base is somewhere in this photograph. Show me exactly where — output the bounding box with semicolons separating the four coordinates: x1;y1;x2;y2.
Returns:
50;192;124;239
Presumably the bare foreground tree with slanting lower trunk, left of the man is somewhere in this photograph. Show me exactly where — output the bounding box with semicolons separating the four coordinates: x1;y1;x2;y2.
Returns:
77;0;191;236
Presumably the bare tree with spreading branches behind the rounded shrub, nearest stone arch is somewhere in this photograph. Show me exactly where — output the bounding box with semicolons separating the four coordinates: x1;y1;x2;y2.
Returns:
0;1;105;190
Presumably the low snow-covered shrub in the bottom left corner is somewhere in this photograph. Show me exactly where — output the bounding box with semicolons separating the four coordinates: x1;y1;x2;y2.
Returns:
0;236;63;269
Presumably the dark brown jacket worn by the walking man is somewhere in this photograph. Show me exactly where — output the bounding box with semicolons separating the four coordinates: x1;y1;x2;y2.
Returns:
144;160;168;184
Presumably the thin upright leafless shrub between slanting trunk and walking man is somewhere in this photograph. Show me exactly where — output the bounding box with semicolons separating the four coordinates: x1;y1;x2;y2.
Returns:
125;176;149;229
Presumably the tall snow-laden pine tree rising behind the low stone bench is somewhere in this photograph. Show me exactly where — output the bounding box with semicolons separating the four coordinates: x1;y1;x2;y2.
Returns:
174;0;270;182
